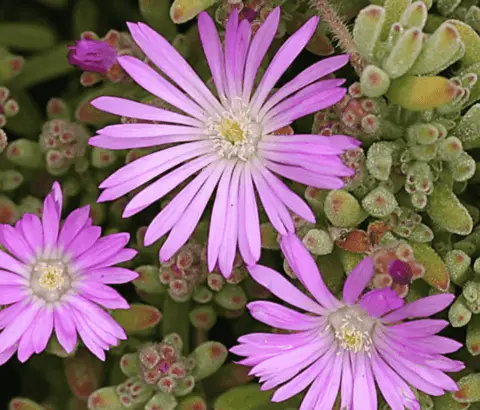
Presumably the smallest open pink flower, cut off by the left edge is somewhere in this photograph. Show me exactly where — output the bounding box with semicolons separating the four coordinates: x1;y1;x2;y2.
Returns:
0;183;138;364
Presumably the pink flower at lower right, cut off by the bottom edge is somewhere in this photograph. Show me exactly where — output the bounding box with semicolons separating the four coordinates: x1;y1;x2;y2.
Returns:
232;235;464;410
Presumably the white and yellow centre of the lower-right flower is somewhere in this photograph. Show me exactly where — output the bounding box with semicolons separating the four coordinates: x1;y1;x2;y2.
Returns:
328;306;377;354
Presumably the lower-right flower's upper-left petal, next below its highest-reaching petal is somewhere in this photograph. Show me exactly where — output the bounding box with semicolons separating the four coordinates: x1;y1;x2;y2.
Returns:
248;265;326;315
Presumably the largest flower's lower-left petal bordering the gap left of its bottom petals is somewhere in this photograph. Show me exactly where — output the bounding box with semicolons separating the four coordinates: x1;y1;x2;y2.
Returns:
160;161;226;262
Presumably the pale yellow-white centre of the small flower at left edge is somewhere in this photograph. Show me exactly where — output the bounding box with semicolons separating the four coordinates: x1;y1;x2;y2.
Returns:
30;260;72;302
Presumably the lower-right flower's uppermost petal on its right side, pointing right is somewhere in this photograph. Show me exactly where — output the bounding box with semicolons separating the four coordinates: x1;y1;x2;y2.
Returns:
382;293;455;323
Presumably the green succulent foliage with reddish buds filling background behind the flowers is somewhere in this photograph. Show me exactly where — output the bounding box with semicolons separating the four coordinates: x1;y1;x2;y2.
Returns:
0;0;480;410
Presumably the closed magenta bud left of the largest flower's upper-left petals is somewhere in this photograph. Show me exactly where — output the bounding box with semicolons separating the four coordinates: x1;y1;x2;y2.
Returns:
68;39;117;74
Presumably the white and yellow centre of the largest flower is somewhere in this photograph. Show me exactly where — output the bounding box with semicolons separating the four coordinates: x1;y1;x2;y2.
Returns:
205;106;262;161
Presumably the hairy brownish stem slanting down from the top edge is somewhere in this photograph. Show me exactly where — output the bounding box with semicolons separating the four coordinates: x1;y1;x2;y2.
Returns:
312;0;367;76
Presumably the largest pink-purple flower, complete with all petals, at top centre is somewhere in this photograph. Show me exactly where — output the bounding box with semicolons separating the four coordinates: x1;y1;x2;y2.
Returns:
90;8;360;276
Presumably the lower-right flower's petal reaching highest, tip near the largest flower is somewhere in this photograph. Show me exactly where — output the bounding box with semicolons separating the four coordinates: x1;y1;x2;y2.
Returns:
280;234;342;309
